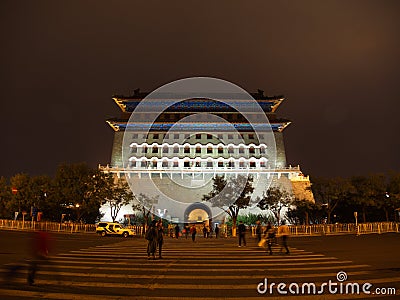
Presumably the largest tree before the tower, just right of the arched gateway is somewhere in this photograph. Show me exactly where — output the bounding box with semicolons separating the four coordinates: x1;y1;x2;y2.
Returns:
203;175;254;236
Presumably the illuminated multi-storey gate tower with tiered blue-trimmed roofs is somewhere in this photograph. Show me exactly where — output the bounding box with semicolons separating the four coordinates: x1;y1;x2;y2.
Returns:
100;90;313;223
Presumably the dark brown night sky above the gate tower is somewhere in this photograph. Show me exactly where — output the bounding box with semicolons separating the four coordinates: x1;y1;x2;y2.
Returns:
0;0;400;177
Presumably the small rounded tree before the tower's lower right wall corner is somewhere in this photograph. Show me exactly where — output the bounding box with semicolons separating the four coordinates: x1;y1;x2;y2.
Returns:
257;187;293;225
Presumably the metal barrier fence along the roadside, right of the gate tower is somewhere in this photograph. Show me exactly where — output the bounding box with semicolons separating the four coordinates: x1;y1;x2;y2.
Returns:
251;222;400;236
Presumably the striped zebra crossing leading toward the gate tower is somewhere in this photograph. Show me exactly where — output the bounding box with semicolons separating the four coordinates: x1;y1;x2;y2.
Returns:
0;238;400;300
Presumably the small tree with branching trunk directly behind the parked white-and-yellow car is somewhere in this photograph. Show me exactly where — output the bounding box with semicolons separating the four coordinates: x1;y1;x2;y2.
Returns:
106;179;134;222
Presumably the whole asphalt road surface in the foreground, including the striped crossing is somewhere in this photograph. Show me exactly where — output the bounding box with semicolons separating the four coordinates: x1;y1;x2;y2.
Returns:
0;231;400;300
